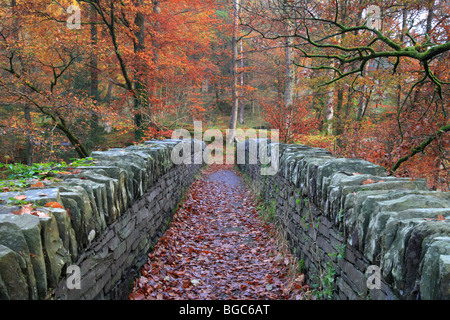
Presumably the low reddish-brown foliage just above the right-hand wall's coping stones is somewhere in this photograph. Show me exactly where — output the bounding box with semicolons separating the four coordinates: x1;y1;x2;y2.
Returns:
336;102;450;190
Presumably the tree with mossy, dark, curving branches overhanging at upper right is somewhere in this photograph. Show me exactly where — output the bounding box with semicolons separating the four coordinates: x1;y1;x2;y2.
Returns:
244;0;450;182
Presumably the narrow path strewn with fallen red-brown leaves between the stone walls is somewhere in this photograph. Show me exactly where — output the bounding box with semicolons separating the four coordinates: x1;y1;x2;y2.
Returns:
130;165;308;300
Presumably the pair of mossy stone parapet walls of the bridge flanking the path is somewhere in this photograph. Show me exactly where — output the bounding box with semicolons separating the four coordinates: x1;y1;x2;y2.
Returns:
0;140;450;299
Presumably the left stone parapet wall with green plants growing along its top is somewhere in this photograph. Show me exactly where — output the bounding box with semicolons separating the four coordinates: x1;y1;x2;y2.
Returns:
0;140;205;299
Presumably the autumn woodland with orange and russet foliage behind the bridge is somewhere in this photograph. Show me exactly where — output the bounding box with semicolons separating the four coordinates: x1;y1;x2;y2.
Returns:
0;0;450;191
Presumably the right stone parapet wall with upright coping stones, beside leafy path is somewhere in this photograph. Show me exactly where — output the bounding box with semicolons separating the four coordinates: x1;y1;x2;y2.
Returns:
238;140;450;300
